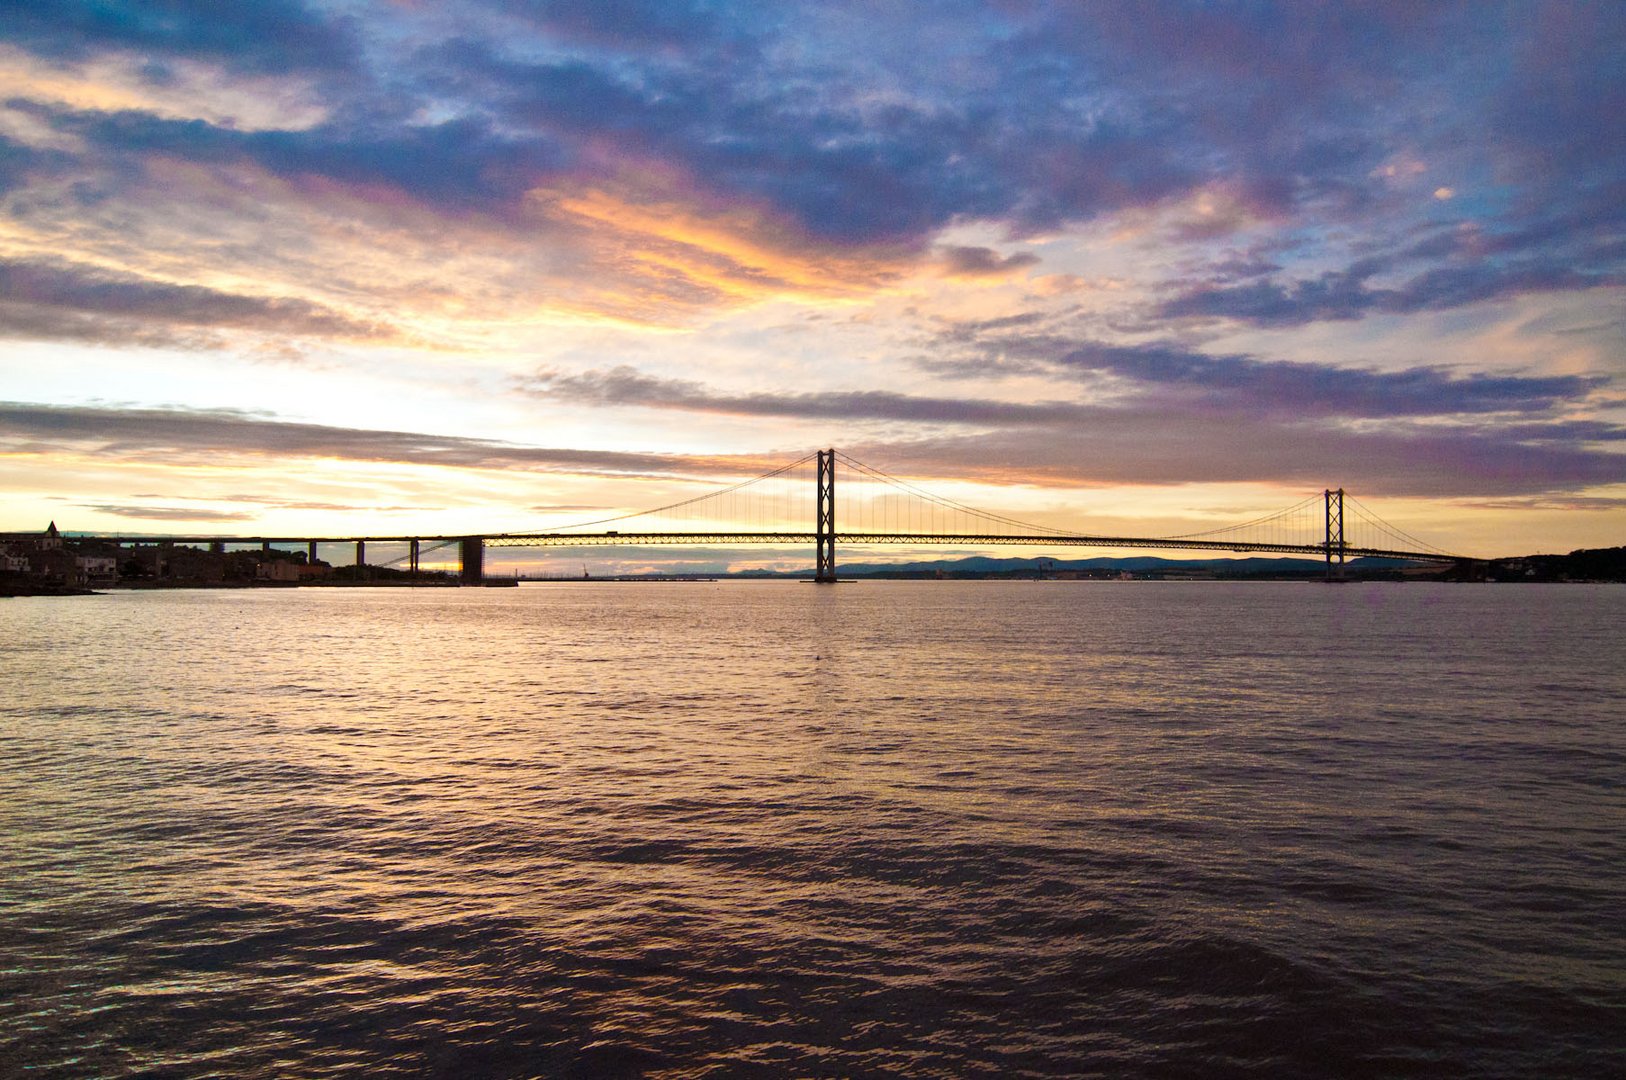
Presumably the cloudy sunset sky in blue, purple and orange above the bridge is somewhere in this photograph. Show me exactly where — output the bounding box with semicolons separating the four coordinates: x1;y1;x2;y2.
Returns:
0;0;1626;569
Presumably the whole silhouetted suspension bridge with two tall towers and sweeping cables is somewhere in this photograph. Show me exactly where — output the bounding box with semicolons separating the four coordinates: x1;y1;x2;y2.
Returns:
75;449;1472;584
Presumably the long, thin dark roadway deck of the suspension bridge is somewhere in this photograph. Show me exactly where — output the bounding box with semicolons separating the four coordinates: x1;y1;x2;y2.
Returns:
79;532;1463;563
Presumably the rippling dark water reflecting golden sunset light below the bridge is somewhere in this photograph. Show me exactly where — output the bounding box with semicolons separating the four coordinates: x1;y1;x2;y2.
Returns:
0;582;1626;1077
